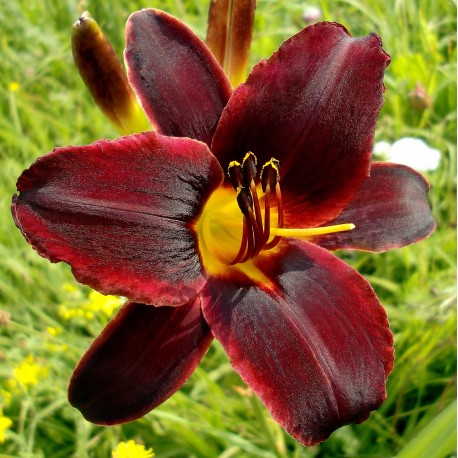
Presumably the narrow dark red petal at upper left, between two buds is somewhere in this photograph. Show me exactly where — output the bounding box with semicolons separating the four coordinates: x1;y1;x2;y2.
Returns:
124;9;232;144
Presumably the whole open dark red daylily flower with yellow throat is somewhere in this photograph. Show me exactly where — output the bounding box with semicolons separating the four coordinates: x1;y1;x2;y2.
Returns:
12;10;435;445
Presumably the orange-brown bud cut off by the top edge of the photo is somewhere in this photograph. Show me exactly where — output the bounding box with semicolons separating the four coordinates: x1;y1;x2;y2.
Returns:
206;0;256;87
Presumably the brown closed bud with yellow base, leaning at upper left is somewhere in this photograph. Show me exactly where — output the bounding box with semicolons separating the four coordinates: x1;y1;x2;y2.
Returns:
72;12;151;135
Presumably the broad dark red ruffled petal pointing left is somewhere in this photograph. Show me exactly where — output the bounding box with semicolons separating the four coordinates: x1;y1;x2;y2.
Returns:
12;132;222;305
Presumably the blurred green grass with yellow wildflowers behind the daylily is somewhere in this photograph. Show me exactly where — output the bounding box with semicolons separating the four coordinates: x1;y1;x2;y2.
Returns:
0;0;456;458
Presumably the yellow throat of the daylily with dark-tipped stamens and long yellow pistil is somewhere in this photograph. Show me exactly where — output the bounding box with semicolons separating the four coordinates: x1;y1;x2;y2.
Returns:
196;152;355;273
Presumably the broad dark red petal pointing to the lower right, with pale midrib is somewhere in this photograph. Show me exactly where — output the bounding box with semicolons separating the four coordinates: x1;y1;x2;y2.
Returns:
202;242;393;445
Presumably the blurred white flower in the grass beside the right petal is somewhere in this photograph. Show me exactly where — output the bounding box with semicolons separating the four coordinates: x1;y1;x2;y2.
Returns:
374;137;441;171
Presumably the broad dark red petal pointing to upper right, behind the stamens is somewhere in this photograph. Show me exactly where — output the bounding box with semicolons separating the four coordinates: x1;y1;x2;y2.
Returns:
212;23;389;226
